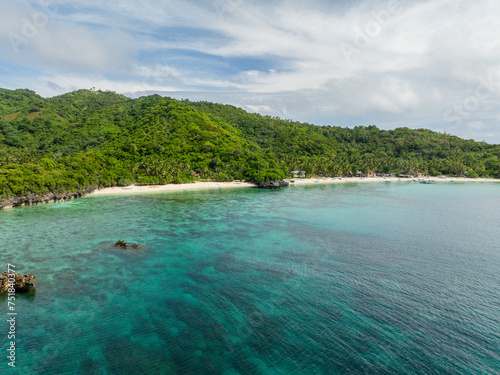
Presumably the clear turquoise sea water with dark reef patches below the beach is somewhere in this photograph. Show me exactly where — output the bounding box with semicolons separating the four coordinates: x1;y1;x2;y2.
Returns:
0;183;500;375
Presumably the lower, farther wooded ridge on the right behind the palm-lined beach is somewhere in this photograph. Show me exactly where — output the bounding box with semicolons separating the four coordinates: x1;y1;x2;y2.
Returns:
191;102;500;177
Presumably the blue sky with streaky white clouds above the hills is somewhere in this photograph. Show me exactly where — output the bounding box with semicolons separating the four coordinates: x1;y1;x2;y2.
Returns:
0;0;500;143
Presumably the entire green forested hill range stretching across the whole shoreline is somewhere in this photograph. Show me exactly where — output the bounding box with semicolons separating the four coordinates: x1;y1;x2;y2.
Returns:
0;89;500;199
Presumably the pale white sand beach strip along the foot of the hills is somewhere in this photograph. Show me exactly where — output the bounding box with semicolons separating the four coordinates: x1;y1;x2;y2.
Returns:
90;177;500;195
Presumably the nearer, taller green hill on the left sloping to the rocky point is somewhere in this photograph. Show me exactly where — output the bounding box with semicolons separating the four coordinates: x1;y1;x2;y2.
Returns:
0;90;285;199
